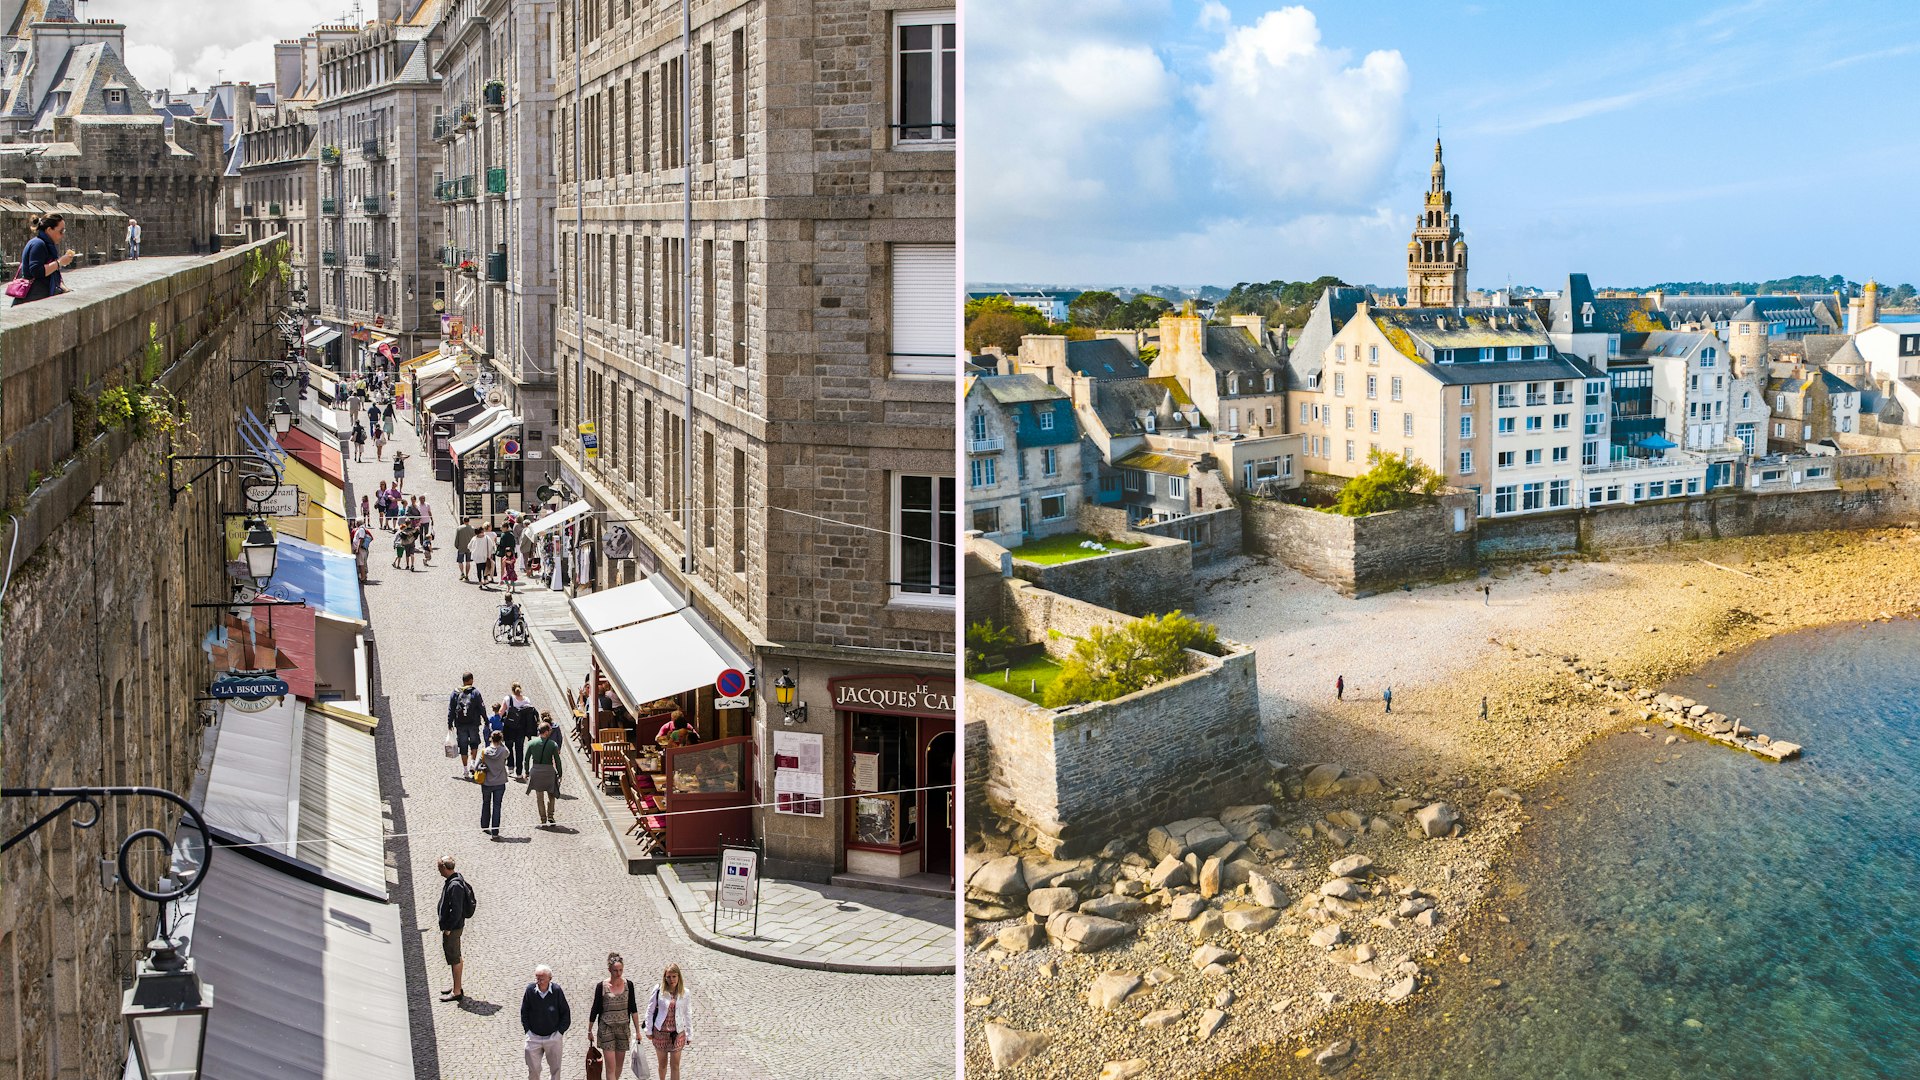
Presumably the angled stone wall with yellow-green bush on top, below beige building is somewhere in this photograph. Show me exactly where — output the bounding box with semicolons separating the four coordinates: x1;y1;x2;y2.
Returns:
1242;494;1475;596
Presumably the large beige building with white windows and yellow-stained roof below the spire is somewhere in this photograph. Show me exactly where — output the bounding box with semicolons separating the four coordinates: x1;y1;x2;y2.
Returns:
1290;304;1605;517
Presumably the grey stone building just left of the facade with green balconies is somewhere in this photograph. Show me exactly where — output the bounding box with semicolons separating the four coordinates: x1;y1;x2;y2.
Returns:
315;0;444;365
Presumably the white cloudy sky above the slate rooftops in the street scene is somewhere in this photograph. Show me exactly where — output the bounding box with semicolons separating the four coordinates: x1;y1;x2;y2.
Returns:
81;0;345;90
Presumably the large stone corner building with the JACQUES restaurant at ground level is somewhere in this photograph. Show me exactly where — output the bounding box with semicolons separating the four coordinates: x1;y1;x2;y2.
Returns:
553;0;960;886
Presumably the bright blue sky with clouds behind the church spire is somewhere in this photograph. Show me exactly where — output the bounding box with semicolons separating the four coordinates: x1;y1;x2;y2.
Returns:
964;0;1920;286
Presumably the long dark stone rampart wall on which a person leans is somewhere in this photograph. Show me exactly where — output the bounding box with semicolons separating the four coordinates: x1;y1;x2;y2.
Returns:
0;239;280;1080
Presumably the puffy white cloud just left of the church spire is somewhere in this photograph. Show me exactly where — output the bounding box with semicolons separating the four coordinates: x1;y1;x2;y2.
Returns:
1192;8;1409;209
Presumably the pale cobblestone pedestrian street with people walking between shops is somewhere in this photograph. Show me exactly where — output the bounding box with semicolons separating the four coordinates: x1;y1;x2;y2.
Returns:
348;421;954;1080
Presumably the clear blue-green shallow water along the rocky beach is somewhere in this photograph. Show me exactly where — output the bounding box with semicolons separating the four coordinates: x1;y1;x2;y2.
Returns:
1228;621;1920;1080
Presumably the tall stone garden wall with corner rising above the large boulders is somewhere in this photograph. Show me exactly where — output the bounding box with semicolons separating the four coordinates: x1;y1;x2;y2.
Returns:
966;580;1267;857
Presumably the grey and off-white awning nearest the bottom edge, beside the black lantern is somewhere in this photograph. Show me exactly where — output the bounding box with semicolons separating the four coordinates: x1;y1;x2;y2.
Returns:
186;851;413;1080
